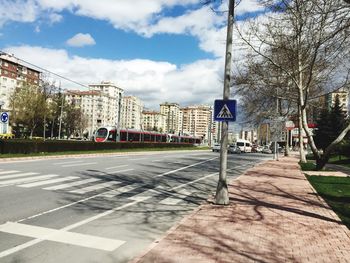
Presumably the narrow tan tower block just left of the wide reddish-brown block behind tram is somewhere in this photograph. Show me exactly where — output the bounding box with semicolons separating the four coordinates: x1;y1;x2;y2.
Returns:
160;102;181;134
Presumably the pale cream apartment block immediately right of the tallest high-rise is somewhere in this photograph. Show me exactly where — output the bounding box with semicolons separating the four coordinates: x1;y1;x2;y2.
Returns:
121;96;143;130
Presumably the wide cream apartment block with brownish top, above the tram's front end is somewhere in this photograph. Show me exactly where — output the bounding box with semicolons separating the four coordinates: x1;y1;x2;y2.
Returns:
65;90;118;137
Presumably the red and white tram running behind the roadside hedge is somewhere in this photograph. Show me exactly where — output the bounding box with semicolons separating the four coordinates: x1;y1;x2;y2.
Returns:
94;127;202;144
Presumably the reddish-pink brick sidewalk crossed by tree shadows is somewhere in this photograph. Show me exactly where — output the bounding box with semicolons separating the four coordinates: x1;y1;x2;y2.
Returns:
132;157;350;263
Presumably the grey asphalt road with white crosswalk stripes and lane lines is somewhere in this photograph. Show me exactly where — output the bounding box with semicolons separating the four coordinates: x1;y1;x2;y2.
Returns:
0;151;271;263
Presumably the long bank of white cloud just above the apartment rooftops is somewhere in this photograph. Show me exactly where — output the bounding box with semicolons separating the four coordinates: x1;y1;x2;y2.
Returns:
5;46;223;109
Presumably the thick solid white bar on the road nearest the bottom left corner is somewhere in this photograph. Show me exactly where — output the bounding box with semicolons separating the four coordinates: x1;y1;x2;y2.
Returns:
0;222;125;251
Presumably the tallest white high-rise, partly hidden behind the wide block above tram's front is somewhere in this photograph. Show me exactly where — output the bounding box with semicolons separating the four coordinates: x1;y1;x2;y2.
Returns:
89;81;124;126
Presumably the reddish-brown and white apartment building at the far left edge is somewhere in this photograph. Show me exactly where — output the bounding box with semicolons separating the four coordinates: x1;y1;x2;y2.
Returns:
0;53;41;111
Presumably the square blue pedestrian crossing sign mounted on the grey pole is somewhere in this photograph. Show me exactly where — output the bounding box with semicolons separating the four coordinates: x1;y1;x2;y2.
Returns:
214;100;237;121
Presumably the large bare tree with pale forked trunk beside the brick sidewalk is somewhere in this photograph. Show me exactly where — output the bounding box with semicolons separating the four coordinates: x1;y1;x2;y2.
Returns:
238;0;350;167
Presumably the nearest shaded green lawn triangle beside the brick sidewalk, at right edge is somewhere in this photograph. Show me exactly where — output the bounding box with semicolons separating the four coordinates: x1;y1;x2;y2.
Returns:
306;176;350;229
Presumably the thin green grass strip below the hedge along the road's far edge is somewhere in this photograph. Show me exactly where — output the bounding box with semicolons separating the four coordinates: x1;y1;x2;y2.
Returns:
0;147;210;158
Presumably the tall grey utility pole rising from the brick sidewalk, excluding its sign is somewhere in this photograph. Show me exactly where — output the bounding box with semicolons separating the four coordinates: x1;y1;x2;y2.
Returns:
215;0;235;205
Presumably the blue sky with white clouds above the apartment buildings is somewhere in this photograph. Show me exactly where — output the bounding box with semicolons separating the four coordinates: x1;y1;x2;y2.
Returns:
0;0;263;110
